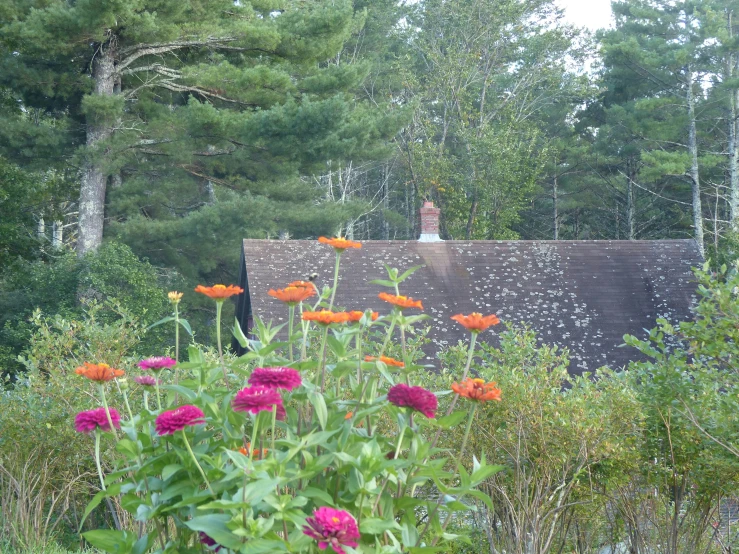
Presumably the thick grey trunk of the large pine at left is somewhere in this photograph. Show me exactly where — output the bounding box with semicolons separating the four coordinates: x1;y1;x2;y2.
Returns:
77;40;116;257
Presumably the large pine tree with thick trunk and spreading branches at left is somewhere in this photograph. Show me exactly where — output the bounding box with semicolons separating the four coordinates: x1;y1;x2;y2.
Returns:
0;0;394;268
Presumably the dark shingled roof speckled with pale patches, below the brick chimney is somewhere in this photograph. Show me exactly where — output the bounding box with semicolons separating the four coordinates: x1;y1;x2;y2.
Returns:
237;240;702;373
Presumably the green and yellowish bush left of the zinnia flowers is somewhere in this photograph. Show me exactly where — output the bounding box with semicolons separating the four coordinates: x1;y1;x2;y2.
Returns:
0;302;149;549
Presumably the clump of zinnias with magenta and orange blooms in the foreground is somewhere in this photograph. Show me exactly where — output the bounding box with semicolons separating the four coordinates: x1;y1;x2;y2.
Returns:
73;241;499;553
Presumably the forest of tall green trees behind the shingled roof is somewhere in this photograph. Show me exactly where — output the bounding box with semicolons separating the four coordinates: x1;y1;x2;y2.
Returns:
0;0;739;375
